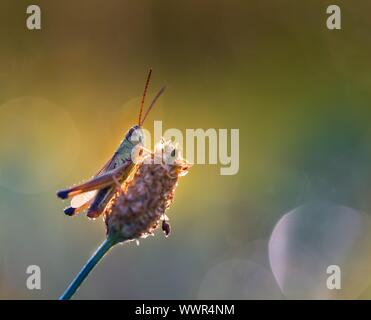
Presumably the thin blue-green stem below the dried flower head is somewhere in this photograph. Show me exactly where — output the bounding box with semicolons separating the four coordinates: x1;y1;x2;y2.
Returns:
59;236;118;300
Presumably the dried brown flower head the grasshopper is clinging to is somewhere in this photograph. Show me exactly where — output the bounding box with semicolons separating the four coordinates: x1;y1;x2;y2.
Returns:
104;140;190;241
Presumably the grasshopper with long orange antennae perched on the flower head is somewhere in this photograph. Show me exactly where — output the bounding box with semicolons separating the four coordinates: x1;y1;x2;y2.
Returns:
57;69;165;218
